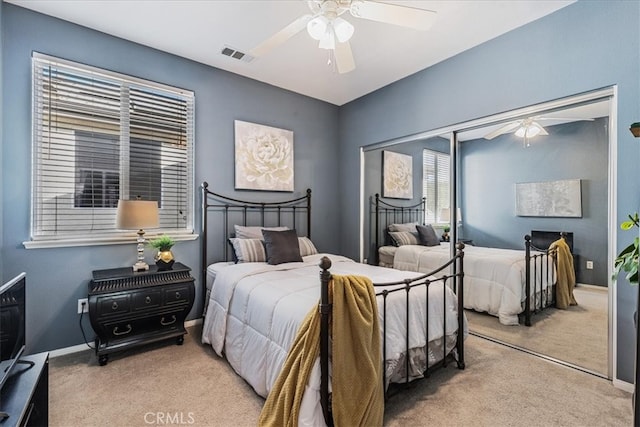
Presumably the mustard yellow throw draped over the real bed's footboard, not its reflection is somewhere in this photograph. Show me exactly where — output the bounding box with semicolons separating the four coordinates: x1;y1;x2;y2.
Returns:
259;274;384;427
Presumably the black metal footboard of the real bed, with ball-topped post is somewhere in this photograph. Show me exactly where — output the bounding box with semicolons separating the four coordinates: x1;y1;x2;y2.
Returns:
319;243;465;426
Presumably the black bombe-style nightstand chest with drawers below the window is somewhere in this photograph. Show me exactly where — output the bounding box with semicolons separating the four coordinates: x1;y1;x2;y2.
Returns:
89;262;195;365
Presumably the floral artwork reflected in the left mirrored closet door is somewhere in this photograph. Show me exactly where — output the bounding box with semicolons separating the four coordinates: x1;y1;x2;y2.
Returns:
382;151;413;199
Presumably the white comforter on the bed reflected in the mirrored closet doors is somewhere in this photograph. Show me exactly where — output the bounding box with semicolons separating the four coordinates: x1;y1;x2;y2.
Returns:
393;243;552;325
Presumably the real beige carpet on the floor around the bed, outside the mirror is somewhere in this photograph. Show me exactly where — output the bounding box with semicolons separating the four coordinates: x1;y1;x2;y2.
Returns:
49;327;632;427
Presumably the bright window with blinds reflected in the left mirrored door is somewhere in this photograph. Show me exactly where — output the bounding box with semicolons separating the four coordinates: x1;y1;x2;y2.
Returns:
422;150;451;225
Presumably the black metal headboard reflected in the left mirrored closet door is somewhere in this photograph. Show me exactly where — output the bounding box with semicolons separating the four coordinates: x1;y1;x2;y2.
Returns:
369;193;426;265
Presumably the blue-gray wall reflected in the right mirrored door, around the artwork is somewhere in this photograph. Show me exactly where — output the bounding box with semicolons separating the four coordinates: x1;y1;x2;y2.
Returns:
459;118;610;286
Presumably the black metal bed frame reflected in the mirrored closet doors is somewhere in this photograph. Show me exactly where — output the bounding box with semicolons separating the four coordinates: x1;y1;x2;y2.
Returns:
370;194;566;326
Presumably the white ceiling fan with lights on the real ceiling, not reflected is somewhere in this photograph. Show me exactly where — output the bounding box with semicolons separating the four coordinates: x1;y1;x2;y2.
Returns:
250;0;436;74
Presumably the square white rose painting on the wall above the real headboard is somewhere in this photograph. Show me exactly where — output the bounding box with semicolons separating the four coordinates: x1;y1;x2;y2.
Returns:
235;120;293;191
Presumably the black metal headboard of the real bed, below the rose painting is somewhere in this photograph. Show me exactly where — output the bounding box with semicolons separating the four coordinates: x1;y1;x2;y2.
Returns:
201;182;311;268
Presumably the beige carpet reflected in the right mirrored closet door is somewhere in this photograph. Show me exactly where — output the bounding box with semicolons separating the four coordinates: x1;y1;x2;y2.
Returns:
466;285;608;376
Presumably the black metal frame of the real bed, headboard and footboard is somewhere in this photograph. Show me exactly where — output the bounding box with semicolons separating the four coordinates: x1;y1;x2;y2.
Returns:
201;182;465;426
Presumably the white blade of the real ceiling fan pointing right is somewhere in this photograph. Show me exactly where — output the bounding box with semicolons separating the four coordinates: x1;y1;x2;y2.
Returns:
349;0;436;31
